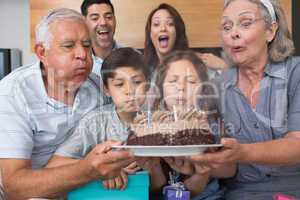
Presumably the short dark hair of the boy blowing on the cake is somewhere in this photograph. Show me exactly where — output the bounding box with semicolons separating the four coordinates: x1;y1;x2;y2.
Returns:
101;47;150;86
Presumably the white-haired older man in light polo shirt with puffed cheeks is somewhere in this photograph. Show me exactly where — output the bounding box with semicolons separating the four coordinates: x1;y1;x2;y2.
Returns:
0;9;132;200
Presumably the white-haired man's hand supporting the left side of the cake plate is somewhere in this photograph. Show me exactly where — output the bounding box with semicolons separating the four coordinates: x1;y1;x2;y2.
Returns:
80;141;134;179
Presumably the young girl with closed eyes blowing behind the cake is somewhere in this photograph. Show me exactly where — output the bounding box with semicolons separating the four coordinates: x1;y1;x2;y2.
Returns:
139;51;231;200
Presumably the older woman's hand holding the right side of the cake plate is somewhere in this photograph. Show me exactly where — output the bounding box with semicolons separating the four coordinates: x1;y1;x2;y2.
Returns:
190;138;246;173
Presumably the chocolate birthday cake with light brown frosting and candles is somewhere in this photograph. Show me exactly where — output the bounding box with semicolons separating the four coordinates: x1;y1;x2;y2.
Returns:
127;110;215;146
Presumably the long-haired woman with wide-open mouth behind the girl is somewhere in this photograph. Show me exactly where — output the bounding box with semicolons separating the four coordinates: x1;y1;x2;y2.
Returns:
144;3;189;74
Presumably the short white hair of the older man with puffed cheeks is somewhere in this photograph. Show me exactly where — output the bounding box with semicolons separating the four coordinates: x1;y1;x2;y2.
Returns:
35;8;85;48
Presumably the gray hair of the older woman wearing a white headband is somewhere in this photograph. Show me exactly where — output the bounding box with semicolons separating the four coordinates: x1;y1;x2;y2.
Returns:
224;0;295;62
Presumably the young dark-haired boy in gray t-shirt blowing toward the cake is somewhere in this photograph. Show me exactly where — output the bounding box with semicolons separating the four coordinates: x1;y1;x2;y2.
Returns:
47;48;149;189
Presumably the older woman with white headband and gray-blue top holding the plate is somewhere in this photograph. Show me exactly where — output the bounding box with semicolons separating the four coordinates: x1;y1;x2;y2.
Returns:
191;0;300;200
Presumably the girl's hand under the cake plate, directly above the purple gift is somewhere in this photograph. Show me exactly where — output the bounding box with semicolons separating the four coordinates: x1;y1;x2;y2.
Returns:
164;157;195;175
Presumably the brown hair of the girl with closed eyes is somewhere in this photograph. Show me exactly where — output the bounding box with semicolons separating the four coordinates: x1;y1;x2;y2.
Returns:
155;50;219;119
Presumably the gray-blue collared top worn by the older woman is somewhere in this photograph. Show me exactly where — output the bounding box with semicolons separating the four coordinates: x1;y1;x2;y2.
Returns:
220;57;300;200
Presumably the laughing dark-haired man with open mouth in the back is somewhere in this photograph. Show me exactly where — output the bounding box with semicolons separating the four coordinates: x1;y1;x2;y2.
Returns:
81;0;119;76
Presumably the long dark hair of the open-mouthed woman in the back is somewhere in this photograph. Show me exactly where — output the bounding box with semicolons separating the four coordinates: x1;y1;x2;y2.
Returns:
144;3;189;70
